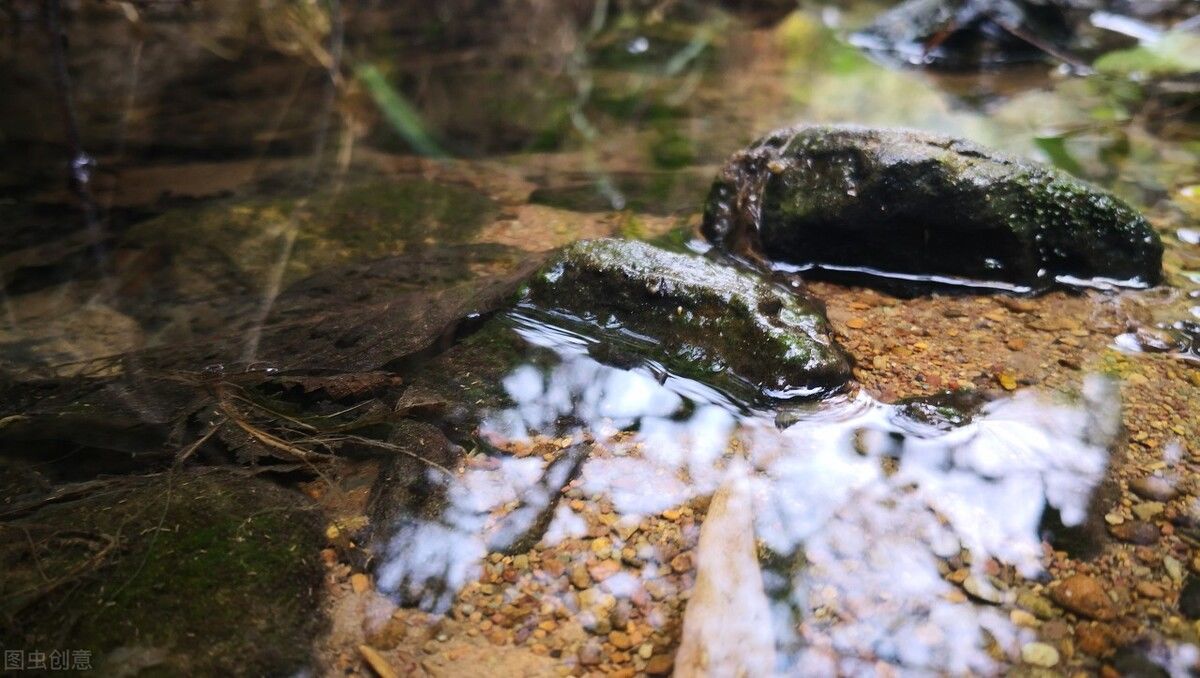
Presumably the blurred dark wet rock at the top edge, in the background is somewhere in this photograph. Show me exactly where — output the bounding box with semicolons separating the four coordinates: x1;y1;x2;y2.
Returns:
851;0;1070;70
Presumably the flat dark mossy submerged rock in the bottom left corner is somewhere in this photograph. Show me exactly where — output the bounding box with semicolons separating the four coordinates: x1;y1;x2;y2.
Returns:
0;472;323;676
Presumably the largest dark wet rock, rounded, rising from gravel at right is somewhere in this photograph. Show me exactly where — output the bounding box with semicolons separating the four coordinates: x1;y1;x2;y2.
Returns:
703;126;1163;292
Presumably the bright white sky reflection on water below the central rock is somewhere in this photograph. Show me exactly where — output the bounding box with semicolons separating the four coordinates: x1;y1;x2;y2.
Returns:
379;316;1120;674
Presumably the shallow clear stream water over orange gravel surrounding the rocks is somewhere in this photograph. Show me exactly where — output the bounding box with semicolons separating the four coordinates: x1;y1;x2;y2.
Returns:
0;0;1200;676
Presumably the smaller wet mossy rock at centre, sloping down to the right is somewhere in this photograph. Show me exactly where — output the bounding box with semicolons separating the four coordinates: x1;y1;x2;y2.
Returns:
527;240;850;397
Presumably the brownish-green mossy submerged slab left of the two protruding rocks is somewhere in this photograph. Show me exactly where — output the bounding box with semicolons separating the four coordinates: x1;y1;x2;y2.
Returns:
124;179;498;296
